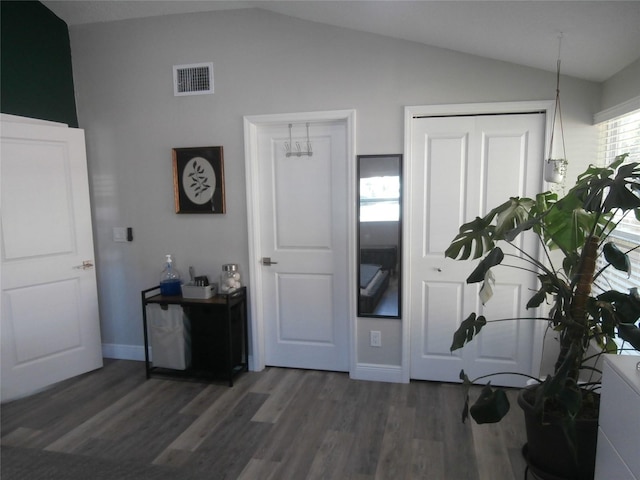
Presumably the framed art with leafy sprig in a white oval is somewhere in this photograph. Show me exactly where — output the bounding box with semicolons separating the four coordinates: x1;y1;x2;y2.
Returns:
173;147;225;213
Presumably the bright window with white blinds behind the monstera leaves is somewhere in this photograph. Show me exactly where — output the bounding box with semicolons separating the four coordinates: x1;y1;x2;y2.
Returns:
597;110;640;352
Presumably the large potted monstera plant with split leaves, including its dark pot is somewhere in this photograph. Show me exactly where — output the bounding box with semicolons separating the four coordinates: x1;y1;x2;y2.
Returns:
445;154;640;480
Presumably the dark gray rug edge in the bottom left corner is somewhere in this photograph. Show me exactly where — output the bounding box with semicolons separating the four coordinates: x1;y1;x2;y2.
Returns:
0;446;212;480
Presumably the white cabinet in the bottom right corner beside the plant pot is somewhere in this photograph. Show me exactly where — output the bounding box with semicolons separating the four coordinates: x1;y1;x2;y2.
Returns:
595;355;640;480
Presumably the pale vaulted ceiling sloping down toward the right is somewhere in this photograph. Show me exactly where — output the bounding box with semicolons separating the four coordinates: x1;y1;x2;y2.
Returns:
42;0;640;82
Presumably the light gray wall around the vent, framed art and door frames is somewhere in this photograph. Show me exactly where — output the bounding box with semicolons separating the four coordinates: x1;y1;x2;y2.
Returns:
70;10;601;365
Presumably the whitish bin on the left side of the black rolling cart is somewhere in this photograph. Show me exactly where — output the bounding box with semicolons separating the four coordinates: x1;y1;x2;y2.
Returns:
147;304;191;370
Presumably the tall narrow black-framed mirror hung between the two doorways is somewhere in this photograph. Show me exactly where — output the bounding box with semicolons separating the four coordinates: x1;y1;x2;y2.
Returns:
358;154;402;318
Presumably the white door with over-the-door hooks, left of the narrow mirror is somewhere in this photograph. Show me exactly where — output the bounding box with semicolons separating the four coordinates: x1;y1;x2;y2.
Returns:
253;116;353;371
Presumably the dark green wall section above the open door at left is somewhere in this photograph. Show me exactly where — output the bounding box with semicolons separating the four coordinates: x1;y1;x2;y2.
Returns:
0;0;78;127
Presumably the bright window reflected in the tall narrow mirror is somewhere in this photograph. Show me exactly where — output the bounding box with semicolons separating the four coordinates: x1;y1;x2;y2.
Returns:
360;175;400;222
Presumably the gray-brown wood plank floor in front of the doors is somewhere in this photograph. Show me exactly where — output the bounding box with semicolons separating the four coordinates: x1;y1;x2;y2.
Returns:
1;360;525;480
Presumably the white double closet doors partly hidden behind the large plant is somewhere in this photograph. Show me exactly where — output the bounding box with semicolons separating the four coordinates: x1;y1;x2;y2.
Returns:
408;113;545;385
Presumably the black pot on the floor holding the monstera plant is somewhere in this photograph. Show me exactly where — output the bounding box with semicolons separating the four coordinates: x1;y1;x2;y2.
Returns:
518;386;598;480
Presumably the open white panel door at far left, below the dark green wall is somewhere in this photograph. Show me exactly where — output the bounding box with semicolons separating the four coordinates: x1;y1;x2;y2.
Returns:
0;116;102;401
